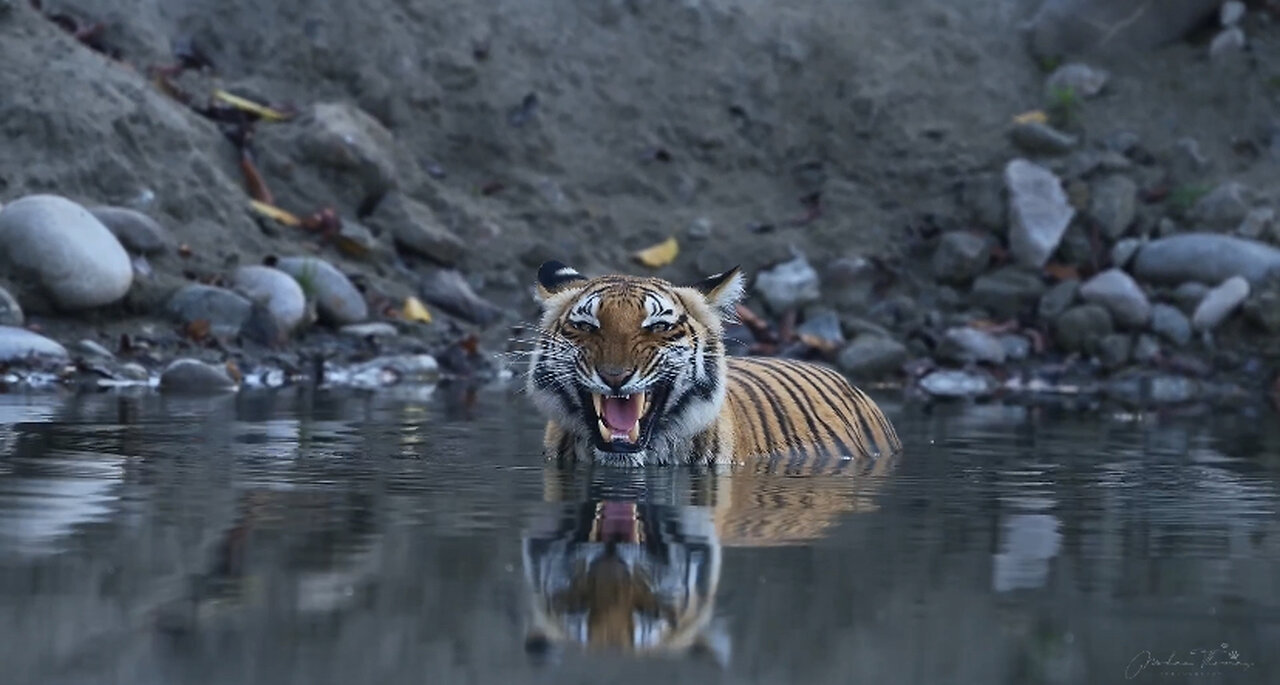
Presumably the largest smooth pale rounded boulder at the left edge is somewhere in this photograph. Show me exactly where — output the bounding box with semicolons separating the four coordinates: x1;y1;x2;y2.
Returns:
0;195;133;310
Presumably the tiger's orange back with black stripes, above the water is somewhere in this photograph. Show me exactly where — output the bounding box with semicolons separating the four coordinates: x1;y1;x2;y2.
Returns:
722;357;902;462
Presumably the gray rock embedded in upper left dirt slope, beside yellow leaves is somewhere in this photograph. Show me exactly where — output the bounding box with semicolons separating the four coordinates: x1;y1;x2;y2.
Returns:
291;102;396;197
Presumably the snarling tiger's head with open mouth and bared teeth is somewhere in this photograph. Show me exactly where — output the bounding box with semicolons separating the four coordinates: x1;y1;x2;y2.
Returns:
527;261;745;466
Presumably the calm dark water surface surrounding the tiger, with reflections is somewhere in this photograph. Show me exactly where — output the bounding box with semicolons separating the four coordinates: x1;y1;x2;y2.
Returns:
0;389;1280;685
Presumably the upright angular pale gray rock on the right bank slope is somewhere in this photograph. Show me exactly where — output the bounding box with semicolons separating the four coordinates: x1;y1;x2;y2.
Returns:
1005;159;1075;269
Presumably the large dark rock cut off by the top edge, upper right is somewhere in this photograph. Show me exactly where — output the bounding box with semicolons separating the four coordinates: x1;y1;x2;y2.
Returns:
1024;0;1219;58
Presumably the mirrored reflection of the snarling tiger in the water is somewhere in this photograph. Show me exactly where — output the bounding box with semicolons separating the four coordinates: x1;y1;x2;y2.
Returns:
522;458;892;666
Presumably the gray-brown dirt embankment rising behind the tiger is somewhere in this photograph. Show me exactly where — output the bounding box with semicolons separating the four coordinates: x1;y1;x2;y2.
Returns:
0;0;1275;404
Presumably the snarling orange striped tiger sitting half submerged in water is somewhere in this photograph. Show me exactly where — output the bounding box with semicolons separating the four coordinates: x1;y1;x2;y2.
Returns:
526;261;902;466
